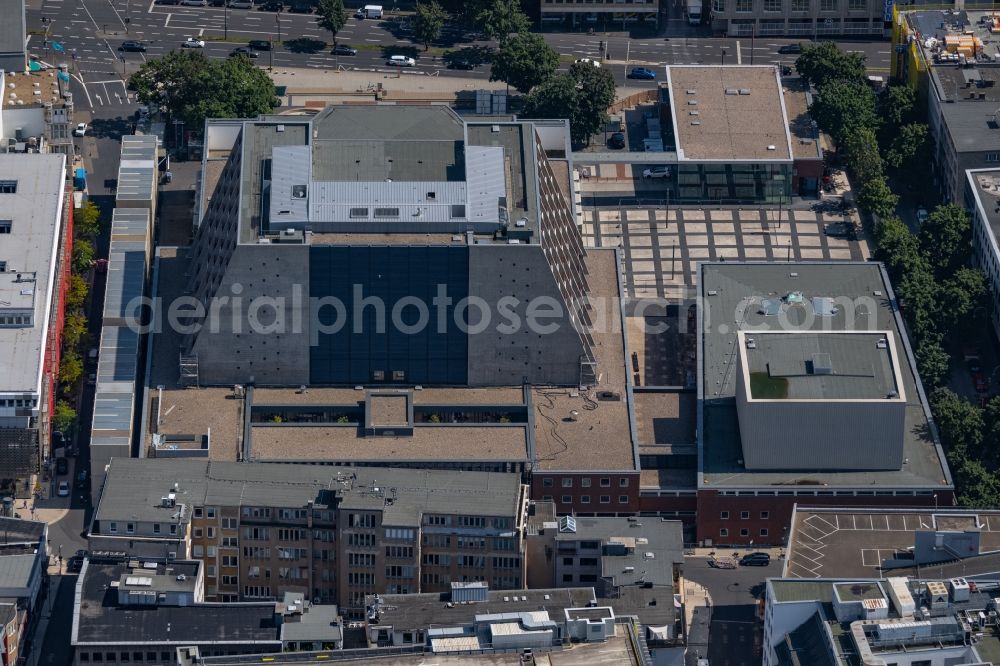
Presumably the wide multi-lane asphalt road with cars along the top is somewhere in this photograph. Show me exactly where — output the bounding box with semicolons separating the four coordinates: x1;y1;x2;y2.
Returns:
29;0;889;115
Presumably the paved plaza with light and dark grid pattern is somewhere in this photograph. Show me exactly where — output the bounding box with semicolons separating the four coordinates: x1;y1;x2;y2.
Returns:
582;207;868;299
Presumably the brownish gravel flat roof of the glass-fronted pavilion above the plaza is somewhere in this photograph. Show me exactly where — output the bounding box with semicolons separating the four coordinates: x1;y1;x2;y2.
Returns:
667;65;792;162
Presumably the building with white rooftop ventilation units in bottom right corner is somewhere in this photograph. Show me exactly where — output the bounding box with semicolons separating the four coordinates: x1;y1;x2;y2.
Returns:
763;577;1000;666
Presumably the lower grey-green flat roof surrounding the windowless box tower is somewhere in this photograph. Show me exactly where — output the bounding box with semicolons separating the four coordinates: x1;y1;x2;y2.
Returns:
698;262;952;490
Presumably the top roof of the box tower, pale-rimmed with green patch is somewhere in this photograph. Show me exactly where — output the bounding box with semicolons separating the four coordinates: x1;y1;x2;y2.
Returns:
740;332;901;400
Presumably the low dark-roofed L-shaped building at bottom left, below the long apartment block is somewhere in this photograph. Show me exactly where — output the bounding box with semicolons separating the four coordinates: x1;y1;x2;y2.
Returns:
71;556;344;666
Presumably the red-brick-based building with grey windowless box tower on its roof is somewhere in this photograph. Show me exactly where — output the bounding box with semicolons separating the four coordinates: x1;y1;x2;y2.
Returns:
697;262;954;547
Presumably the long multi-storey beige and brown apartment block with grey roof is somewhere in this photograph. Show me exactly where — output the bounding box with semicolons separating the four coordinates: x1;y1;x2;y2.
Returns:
89;459;527;616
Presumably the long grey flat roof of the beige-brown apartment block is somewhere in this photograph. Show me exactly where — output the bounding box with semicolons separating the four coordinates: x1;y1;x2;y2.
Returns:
95;458;521;527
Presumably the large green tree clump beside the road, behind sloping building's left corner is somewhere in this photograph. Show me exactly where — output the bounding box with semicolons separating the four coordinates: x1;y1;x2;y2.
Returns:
128;49;278;134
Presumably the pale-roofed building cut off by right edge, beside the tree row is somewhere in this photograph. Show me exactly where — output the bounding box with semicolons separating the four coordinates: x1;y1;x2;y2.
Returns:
965;169;1000;336
